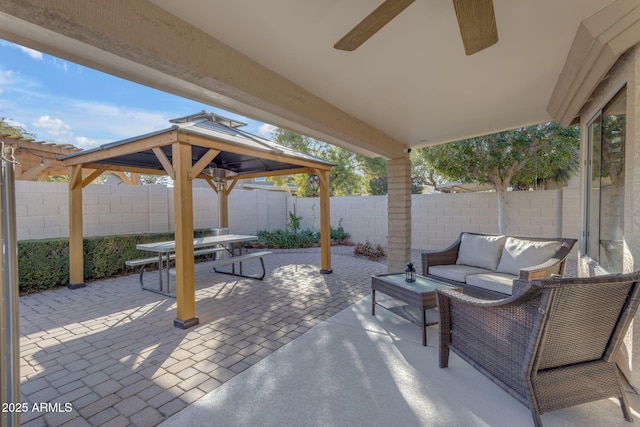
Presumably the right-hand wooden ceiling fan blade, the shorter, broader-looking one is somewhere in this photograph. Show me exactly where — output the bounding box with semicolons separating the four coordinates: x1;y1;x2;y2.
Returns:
453;0;498;55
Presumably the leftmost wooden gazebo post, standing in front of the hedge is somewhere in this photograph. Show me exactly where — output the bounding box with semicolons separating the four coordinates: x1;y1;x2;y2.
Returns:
67;164;87;289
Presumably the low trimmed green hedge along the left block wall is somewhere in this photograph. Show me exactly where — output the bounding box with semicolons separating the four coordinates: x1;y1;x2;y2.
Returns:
18;230;210;293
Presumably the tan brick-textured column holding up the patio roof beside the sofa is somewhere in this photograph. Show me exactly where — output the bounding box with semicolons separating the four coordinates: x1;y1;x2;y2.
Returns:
387;155;411;273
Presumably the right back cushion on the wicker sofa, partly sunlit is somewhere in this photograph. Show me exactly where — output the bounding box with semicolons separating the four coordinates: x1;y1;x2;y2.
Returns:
497;237;562;275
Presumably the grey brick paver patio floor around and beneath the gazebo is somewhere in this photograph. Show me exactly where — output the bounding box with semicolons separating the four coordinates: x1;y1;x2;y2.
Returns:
20;251;386;426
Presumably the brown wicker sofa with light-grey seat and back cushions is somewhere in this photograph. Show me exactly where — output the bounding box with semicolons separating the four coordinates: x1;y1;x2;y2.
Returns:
422;232;576;299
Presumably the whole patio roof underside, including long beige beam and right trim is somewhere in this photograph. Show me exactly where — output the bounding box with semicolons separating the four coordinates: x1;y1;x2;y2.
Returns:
0;0;640;158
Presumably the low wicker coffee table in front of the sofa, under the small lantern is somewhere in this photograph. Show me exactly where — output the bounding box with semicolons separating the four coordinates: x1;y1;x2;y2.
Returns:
371;273;455;346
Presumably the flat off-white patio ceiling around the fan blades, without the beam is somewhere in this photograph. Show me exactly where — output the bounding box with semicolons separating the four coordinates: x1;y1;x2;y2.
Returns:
152;0;611;147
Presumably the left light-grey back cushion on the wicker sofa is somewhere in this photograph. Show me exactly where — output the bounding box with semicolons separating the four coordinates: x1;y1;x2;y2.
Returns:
456;233;507;271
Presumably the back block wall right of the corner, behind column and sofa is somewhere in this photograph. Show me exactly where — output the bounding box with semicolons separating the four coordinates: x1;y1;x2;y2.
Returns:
288;188;580;250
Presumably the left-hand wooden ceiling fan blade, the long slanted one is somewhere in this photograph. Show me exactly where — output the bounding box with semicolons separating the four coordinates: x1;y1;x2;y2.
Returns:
333;0;415;51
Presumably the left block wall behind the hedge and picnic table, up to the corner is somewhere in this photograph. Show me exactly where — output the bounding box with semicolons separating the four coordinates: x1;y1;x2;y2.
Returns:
16;181;287;240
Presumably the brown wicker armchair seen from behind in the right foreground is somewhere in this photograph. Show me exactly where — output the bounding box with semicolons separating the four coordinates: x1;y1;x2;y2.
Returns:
437;272;640;426
